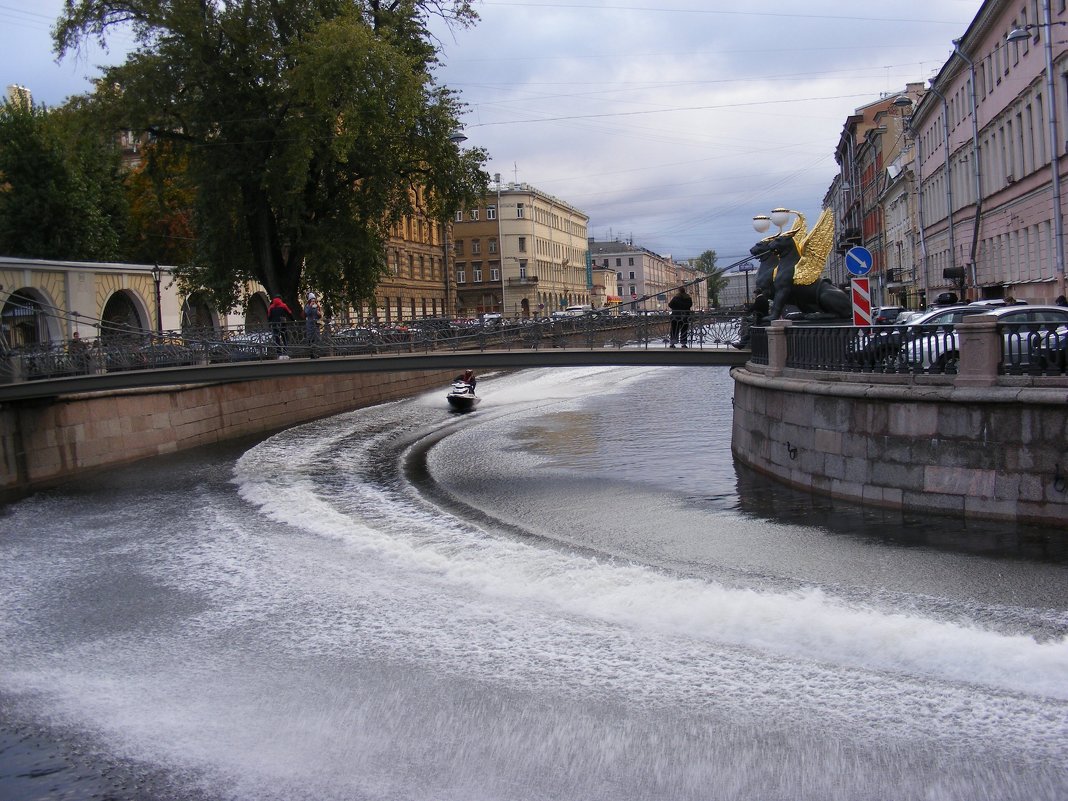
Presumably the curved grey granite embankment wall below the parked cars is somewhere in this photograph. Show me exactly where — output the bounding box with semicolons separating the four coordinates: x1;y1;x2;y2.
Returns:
732;365;1068;527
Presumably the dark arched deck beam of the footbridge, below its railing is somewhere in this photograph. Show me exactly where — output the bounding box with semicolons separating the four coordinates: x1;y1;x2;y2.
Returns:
0;347;750;403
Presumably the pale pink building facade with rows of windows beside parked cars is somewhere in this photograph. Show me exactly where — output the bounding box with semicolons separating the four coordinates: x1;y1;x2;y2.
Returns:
910;0;1068;303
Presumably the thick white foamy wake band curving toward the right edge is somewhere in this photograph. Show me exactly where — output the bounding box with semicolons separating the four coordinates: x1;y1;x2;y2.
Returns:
235;374;1068;700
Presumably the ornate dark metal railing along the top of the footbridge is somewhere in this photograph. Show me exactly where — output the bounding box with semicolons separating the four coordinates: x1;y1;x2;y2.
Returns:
0;311;740;382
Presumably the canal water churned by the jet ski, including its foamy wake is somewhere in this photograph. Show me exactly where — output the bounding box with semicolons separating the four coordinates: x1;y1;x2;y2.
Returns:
0;367;1068;801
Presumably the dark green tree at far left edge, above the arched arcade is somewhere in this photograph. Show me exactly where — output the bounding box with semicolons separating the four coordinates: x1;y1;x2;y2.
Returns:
0;100;126;261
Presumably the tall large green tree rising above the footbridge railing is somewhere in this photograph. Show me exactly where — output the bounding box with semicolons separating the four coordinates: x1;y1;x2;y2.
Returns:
53;0;488;309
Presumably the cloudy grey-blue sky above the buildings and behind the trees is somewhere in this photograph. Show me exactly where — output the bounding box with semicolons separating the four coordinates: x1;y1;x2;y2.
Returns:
0;0;981;266
